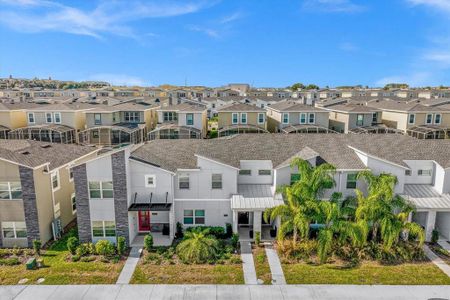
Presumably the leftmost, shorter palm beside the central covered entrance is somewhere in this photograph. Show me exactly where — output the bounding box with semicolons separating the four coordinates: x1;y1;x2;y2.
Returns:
264;186;314;247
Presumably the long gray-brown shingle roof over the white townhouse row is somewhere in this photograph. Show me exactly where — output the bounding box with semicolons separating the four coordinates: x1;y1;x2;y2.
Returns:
131;134;450;172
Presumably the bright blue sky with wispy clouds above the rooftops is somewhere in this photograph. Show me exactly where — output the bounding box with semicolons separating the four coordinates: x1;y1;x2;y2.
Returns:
0;0;450;87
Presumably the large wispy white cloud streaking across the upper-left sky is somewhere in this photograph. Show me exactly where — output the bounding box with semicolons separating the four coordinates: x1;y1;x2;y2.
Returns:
0;0;216;38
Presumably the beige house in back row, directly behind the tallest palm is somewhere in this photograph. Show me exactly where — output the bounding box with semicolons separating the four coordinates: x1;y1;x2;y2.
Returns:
267;101;330;133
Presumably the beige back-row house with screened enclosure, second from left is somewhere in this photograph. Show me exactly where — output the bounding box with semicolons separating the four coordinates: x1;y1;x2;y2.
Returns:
9;103;93;144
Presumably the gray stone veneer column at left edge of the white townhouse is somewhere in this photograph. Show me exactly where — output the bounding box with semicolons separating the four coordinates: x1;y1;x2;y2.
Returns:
72;164;92;243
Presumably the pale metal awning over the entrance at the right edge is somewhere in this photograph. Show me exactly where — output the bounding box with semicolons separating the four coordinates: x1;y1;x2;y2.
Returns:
402;184;450;211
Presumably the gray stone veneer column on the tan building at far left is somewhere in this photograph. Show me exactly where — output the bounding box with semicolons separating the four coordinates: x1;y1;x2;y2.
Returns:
19;166;40;247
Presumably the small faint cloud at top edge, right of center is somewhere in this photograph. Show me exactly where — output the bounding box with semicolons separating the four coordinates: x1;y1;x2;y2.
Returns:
303;0;367;13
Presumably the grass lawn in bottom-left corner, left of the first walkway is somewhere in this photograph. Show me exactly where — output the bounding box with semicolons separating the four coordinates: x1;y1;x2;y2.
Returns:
0;230;125;285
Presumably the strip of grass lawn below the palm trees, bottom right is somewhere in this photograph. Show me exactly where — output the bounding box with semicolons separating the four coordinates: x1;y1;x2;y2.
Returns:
282;262;450;285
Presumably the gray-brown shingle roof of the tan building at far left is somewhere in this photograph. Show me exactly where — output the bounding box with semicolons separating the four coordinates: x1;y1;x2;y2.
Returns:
0;140;96;170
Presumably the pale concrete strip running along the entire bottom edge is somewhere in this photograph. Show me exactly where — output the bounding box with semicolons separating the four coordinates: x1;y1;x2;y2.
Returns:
0;285;450;300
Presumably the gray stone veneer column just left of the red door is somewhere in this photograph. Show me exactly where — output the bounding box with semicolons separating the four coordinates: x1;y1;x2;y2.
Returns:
111;151;130;245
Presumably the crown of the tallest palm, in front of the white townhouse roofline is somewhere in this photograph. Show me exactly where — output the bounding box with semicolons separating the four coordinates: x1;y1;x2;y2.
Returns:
291;157;336;201
